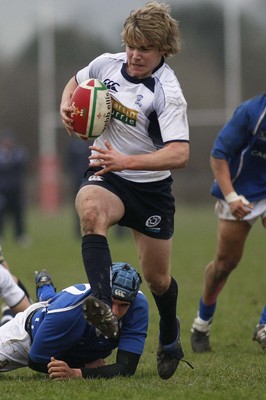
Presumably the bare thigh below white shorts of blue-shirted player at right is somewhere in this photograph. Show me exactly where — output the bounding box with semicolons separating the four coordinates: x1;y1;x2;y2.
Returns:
216;219;251;263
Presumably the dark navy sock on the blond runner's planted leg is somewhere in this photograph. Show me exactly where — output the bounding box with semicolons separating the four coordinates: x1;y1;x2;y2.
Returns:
152;277;178;345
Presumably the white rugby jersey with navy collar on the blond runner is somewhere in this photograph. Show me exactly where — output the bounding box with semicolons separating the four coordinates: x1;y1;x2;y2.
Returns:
76;53;189;182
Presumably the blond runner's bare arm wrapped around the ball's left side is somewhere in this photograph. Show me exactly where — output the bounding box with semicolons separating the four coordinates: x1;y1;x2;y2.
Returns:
60;76;78;136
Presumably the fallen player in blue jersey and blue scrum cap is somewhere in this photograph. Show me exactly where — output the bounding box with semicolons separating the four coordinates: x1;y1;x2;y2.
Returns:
0;263;148;378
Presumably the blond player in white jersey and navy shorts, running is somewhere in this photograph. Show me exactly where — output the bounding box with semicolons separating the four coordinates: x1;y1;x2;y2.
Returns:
60;1;189;379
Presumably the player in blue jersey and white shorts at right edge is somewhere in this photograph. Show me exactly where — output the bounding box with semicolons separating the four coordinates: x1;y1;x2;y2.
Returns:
191;94;266;352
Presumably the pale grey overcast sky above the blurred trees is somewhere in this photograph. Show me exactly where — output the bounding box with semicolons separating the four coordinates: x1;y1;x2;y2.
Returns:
0;0;266;57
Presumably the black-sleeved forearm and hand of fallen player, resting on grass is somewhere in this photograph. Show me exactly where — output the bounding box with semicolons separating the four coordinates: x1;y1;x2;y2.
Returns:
47;350;140;380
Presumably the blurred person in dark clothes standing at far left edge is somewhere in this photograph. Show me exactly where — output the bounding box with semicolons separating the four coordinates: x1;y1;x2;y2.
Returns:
0;130;30;246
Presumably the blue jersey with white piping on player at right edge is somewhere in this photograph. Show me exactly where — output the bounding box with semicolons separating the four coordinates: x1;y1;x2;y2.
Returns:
211;94;266;202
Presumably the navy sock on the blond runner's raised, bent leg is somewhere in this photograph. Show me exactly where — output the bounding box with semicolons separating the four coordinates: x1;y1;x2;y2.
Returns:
82;234;112;307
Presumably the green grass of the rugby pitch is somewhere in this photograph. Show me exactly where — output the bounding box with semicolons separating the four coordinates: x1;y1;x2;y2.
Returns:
0;205;266;400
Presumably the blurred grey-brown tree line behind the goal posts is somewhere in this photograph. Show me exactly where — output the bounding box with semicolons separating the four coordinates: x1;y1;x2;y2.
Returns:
0;3;266;208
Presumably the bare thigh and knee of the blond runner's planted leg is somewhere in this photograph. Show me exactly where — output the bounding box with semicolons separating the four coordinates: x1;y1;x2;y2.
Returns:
132;230;172;292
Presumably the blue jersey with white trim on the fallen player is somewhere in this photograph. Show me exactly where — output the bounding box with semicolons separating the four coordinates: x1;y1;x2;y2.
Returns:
29;284;148;368
